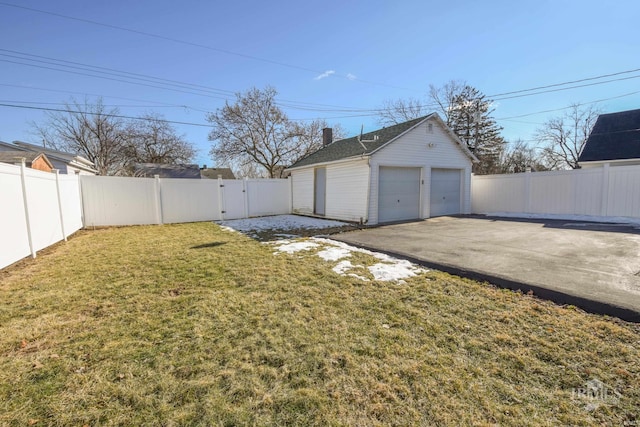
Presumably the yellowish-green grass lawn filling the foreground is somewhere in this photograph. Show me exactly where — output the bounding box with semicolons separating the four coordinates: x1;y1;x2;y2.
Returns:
0;223;640;426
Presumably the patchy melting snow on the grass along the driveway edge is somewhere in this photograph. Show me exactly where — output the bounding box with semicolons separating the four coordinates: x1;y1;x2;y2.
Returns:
271;237;427;283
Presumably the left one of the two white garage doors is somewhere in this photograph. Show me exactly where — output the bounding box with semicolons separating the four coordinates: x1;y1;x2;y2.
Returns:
378;167;420;222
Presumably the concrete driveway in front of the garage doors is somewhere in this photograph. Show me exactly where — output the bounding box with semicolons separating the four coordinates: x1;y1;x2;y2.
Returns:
332;216;640;322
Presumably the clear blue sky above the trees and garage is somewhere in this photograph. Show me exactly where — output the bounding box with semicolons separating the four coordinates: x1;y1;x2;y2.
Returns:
0;0;640;166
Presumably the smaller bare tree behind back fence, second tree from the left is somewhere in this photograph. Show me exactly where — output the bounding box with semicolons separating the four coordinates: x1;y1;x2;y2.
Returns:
126;113;195;164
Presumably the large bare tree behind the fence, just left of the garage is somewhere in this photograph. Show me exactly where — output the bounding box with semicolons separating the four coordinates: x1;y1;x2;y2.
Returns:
207;87;340;178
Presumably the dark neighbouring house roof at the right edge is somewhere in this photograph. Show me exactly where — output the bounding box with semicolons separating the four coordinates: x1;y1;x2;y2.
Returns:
578;110;640;162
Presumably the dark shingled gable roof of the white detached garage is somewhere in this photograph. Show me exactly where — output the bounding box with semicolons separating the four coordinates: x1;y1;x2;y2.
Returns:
288;113;477;169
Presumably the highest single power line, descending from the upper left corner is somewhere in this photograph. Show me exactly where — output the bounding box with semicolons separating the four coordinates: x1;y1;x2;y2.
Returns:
0;2;414;91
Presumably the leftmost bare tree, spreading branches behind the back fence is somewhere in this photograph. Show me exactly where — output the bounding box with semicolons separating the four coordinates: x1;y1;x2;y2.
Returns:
32;99;127;175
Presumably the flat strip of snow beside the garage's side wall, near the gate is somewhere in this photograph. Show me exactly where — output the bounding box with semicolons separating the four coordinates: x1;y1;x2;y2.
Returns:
216;215;348;233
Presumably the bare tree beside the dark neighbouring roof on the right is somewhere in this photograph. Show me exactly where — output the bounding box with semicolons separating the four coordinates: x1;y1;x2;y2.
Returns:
535;104;600;169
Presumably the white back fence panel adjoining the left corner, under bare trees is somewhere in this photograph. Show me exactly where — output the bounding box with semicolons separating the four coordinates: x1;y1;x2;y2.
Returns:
80;175;161;227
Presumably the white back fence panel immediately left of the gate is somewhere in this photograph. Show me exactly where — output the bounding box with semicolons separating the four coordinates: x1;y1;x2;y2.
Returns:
160;179;222;223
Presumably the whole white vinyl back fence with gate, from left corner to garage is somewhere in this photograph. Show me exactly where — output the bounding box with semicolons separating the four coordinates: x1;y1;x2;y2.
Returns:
80;175;291;227
